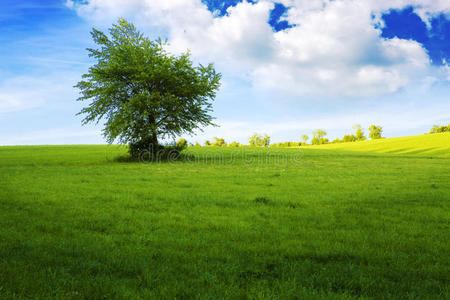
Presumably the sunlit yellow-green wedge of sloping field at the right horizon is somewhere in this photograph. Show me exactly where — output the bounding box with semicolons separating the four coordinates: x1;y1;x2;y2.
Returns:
315;132;450;157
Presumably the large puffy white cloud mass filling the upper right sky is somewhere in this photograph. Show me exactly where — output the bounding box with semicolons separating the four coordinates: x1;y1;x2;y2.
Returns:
68;0;450;97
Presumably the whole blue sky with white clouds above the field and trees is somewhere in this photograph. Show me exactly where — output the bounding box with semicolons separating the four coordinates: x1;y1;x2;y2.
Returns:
0;0;450;145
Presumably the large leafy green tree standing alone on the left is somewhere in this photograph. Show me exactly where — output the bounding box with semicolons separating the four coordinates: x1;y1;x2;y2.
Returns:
76;19;221;155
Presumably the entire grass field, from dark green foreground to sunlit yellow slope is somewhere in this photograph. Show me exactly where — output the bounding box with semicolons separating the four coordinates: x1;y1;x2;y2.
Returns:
0;133;450;299
